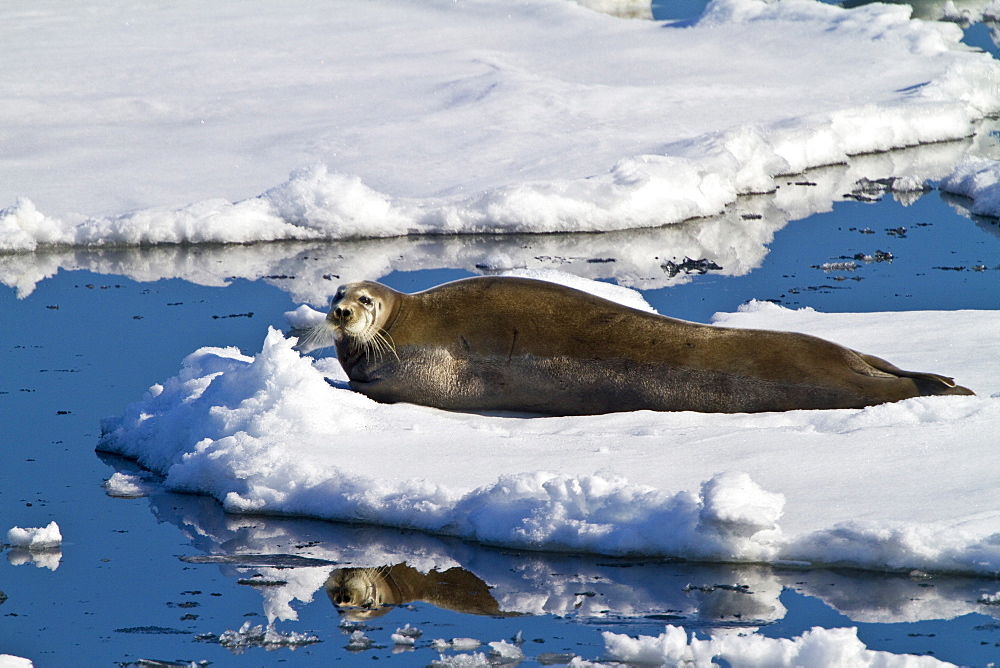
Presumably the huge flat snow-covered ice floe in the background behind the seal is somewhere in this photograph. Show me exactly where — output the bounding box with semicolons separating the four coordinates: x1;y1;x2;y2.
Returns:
0;0;1000;251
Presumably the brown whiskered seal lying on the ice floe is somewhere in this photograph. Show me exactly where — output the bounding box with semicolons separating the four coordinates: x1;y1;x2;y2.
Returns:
312;277;973;415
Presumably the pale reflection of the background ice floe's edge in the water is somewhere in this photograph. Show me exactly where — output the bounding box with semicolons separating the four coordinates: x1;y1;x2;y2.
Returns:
0;130;988;306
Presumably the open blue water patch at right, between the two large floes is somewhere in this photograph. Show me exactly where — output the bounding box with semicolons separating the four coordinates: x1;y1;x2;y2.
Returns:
647;193;1000;322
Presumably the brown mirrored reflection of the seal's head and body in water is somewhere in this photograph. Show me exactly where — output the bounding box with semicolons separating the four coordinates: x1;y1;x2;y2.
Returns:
323;562;503;621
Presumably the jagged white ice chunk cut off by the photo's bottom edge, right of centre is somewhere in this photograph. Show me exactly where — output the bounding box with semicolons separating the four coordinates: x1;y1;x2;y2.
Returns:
604;626;953;668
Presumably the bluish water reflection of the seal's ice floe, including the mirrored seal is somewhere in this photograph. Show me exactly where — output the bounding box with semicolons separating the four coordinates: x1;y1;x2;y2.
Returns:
137;472;1000;628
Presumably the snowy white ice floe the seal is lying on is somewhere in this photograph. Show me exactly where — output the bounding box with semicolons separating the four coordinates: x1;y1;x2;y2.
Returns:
99;276;1000;573
